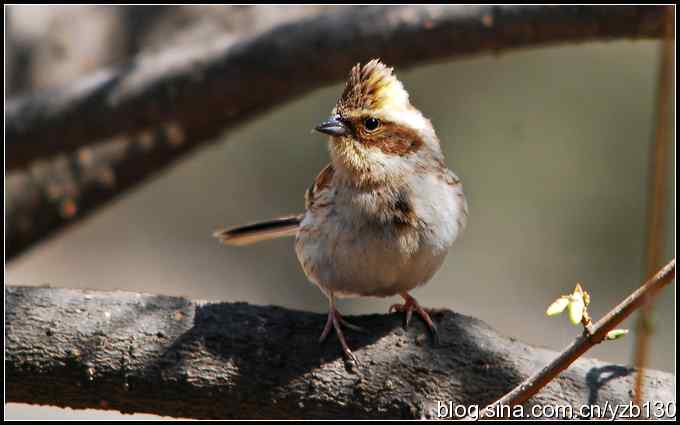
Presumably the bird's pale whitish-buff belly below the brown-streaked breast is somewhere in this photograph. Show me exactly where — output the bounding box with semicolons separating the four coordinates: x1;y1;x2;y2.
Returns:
295;171;467;297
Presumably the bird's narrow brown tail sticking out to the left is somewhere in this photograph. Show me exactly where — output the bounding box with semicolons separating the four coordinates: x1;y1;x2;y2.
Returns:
213;214;304;245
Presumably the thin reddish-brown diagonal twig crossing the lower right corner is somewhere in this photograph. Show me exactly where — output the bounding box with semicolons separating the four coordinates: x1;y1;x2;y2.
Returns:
472;258;675;416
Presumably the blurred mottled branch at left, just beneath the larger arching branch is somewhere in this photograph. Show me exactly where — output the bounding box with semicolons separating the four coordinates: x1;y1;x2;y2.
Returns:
5;124;195;260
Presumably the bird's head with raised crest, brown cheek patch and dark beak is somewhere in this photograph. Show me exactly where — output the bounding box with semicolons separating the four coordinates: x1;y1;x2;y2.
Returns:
316;59;441;186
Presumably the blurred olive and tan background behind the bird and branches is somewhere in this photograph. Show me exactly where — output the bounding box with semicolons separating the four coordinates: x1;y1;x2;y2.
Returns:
5;6;675;419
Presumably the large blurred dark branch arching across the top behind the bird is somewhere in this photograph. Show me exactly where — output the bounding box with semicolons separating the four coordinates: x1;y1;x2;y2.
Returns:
5;6;663;169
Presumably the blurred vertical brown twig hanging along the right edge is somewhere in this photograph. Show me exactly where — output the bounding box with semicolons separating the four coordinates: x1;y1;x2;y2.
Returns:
634;6;675;405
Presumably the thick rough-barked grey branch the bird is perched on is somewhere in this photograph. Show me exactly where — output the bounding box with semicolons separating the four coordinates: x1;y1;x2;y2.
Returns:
5;286;675;419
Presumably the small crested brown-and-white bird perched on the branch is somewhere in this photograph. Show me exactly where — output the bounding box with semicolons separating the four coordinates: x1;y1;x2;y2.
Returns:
214;59;468;363
